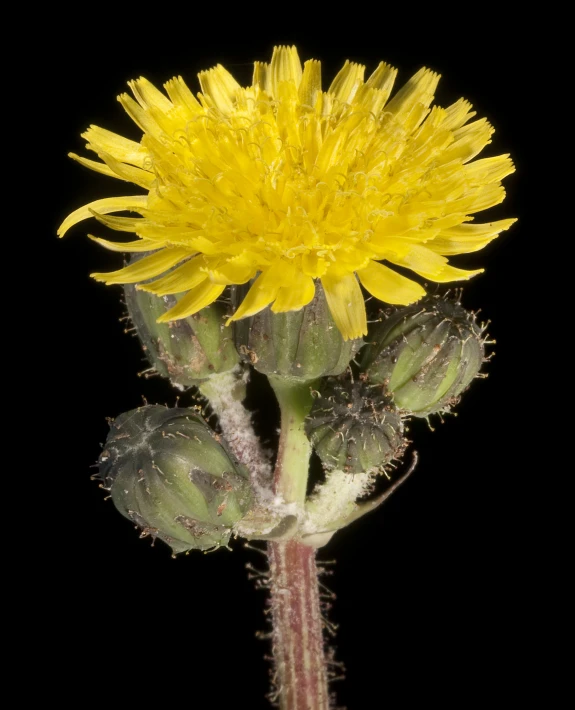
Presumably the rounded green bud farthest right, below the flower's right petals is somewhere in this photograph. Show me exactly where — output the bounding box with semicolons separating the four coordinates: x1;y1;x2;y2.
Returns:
360;296;485;417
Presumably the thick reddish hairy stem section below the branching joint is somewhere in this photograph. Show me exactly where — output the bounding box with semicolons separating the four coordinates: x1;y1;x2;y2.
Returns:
268;540;329;710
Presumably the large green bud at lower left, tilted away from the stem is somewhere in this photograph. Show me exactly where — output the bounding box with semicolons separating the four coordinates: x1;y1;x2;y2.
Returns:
99;405;252;553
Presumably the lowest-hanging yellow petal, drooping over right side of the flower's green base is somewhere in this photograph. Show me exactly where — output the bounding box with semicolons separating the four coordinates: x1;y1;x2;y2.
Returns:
321;271;367;340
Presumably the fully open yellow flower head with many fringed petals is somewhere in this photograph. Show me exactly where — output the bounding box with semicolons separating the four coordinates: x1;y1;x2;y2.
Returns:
58;47;515;339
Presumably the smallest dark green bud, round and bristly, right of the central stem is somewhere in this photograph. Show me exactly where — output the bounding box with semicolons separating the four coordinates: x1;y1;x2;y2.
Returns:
306;380;405;473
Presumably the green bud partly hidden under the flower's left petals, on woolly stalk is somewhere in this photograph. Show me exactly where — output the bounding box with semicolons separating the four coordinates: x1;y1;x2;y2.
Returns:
124;284;239;388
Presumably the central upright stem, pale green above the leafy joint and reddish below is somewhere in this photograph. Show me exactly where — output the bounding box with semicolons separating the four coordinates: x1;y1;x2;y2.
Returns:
268;384;329;710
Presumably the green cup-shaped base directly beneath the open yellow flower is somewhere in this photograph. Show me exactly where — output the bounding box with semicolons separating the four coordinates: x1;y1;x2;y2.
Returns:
234;283;363;381
